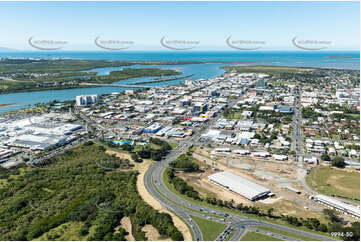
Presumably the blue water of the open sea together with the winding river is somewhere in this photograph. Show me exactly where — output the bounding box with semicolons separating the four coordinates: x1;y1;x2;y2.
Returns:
0;50;360;113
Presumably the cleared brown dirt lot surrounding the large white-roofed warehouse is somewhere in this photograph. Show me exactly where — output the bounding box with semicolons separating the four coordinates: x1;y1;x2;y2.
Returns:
188;147;334;221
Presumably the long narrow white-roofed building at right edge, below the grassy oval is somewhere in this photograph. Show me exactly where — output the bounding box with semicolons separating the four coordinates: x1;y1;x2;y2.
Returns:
310;195;360;218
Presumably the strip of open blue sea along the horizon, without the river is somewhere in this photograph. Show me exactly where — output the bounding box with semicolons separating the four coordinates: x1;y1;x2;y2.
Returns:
0;50;360;70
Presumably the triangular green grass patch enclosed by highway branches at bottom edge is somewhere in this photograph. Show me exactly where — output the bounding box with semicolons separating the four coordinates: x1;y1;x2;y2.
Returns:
190;215;227;241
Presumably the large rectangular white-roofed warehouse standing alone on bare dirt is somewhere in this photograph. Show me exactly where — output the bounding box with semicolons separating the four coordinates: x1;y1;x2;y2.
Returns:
208;171;271;201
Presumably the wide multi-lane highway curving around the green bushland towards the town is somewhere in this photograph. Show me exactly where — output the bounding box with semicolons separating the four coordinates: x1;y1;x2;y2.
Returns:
144;94;332;241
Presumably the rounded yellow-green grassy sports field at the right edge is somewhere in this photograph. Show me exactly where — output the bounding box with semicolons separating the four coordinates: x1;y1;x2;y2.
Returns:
306;167;360;199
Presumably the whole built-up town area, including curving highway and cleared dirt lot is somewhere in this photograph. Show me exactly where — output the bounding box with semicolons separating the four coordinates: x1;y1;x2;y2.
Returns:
0;66;360;240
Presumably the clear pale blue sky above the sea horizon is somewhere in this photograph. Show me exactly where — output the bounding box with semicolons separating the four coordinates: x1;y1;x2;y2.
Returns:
0;2;360;50
